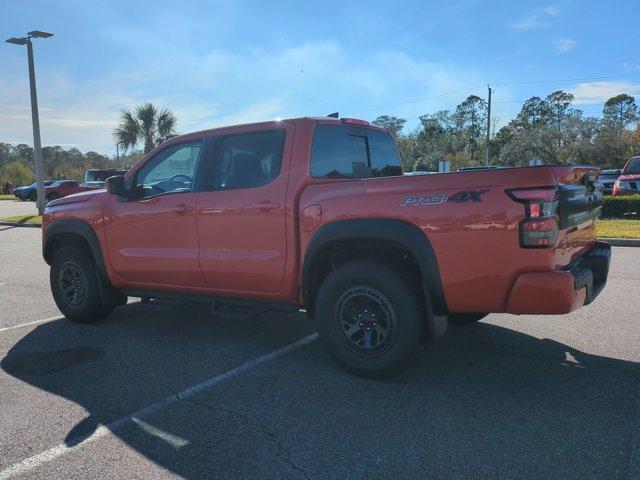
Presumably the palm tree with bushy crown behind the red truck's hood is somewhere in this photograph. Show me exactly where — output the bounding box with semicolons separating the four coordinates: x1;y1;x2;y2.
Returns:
113;102;178;155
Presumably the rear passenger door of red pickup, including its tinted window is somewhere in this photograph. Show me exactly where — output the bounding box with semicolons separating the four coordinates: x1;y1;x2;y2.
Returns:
196;125;294;294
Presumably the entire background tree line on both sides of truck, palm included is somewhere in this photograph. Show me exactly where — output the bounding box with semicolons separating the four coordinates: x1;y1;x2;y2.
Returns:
0;90;640;185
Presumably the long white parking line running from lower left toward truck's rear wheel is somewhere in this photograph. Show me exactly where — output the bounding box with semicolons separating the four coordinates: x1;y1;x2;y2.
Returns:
0;333;318;480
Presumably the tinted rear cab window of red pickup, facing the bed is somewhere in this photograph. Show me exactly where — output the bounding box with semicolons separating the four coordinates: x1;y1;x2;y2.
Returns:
311;125;402;178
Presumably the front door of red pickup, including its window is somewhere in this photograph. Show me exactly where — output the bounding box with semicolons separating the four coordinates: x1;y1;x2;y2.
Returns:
104;140;205;287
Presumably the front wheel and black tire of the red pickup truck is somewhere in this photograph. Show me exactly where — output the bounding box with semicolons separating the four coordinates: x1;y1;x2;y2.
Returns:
49;245;115;323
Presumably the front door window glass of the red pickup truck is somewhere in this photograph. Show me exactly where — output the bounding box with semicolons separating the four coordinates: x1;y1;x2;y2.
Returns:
135;141;202;198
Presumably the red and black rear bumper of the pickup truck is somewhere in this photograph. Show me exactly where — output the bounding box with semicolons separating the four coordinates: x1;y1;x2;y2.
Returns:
506;242;611;315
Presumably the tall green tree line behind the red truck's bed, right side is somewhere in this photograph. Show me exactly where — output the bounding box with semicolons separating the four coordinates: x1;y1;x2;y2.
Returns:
373;90;640;171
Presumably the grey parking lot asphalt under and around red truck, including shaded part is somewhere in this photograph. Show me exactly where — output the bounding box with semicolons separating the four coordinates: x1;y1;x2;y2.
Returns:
0;220;640;479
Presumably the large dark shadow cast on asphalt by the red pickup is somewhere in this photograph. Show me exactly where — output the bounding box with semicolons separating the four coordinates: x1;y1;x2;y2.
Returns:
0;304;640;479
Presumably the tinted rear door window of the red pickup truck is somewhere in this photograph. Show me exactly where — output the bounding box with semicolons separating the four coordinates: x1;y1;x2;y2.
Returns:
208;130;286;190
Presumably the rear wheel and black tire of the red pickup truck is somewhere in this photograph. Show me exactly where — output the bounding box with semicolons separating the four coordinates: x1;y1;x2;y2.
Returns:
316;260;427;378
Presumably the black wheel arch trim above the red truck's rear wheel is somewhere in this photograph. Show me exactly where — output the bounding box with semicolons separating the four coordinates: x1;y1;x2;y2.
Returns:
302;218;448;315
